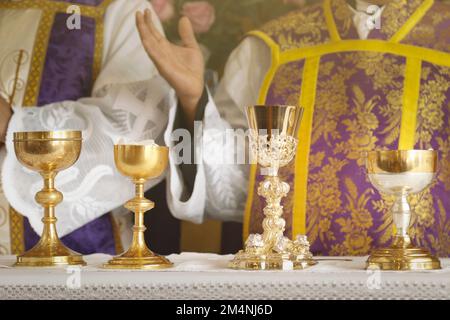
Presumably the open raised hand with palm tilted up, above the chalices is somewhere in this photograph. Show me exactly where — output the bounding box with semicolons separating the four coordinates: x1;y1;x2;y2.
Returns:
136;10;205;123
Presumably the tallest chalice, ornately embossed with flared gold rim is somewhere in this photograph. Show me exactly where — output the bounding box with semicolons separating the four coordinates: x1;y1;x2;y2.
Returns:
229;106;317;270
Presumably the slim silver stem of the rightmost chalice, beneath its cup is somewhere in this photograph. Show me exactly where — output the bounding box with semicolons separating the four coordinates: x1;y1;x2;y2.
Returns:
392;194;411;248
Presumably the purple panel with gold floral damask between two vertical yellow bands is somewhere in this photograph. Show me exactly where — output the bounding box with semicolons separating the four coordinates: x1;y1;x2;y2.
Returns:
307;52;405;255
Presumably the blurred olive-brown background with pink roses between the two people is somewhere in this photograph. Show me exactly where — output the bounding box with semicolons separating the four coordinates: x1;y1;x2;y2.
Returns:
150;0;308;89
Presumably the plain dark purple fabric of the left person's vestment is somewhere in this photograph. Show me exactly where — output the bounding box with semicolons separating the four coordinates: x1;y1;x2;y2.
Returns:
24;6;116;254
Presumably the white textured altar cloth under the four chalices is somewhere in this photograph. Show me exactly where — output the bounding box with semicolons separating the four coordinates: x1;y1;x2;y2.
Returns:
0;253;450;300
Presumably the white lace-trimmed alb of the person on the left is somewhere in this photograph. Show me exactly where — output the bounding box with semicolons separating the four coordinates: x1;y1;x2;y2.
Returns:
0;0;173;242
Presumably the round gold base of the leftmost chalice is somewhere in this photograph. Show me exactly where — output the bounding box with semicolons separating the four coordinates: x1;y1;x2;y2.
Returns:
14;240;86;267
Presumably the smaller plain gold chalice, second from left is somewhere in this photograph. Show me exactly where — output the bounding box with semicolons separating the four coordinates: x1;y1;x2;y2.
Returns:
103;145;172;269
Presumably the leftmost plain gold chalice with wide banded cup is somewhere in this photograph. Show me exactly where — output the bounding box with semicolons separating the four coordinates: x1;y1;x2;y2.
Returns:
14;131;86;267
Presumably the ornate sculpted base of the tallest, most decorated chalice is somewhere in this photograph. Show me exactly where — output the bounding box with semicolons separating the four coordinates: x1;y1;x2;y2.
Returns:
229;250;317;270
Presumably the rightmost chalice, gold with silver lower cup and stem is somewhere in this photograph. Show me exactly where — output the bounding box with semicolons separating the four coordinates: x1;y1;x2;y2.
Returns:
366;150;441;270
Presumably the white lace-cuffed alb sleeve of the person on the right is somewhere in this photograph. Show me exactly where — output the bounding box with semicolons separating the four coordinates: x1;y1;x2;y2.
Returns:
166;1;378;222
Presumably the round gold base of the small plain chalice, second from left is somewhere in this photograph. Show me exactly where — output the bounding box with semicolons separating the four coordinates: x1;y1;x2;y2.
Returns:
103;251;173;270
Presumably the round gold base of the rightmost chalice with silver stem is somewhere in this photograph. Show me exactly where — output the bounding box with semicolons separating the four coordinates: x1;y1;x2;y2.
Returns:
366;247;441;271
